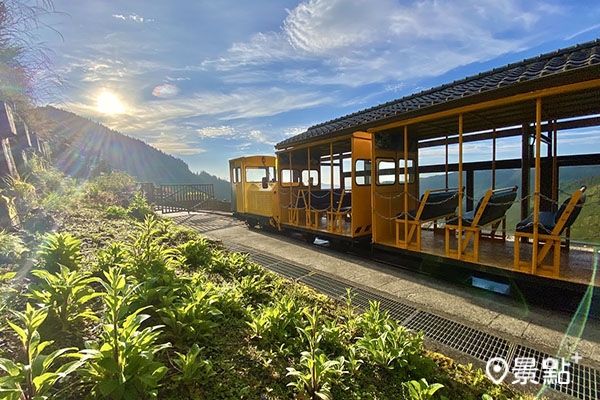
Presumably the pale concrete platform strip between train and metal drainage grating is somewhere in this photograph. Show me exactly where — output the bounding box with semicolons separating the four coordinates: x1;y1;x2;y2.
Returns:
167;213;600;398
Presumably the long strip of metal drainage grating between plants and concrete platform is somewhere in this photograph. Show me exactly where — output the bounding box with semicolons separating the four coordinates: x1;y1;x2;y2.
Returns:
212;233;600;400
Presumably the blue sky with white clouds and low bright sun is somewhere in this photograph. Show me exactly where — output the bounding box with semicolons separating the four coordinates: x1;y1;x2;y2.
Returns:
38;0;600;178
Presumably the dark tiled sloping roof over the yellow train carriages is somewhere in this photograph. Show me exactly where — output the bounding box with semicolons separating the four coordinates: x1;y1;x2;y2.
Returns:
275;39;600;149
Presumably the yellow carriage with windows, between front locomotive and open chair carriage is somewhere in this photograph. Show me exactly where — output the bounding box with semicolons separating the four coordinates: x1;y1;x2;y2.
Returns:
276;132;372;242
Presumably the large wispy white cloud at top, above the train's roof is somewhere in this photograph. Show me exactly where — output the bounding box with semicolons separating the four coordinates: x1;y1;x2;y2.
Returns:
202;0;560;87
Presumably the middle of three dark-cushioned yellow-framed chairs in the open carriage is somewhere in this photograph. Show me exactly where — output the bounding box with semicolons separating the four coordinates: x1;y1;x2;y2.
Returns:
446;186;518;262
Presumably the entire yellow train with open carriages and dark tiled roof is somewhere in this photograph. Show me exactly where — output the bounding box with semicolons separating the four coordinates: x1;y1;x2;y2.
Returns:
230;40;600;287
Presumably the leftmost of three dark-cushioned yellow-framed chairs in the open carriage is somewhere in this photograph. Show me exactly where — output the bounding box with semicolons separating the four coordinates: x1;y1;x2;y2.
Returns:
396;189;458;251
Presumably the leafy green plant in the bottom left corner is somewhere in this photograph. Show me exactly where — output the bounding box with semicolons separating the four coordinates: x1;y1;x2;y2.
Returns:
0;304;83;400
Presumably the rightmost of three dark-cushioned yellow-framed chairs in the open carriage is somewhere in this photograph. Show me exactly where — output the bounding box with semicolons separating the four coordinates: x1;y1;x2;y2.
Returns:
514;185;586;276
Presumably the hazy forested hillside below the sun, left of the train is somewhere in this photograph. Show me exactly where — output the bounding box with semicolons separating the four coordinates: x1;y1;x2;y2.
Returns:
32;106;230;200
